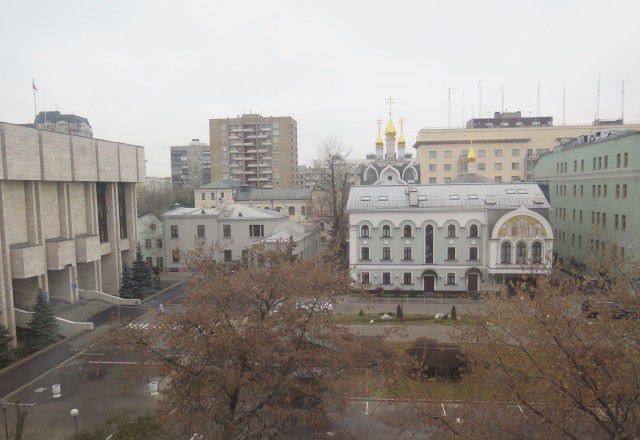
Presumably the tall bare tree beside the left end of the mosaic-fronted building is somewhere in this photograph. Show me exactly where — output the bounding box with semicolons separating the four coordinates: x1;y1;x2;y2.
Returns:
311;137;353;264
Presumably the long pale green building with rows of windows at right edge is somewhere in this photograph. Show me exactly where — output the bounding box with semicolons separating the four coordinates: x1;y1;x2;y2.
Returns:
534;130;640;271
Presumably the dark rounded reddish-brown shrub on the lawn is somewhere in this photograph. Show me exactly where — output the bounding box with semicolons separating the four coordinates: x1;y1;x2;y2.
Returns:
406;338;467;380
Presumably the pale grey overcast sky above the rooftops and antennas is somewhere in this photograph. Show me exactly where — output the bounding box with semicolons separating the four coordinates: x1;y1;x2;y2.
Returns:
0;0;640;176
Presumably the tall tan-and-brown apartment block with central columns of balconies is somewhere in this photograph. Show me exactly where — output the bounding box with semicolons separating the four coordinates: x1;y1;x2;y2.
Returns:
209;114;299;188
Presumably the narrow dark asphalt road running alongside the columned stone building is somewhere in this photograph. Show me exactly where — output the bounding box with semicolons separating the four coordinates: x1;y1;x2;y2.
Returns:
0;285;185;400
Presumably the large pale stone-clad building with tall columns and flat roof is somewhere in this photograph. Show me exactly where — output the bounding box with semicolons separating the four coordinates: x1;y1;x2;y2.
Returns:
0;123;145;344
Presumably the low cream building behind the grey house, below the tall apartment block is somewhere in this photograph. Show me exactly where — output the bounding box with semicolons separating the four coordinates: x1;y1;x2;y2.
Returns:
194;180;313;223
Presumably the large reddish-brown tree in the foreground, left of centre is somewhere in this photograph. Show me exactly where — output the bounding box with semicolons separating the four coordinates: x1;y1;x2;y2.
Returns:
116;243;372;439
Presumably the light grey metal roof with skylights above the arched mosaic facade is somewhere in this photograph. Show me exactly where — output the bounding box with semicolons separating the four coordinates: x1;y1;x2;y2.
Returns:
347;182;549;211
